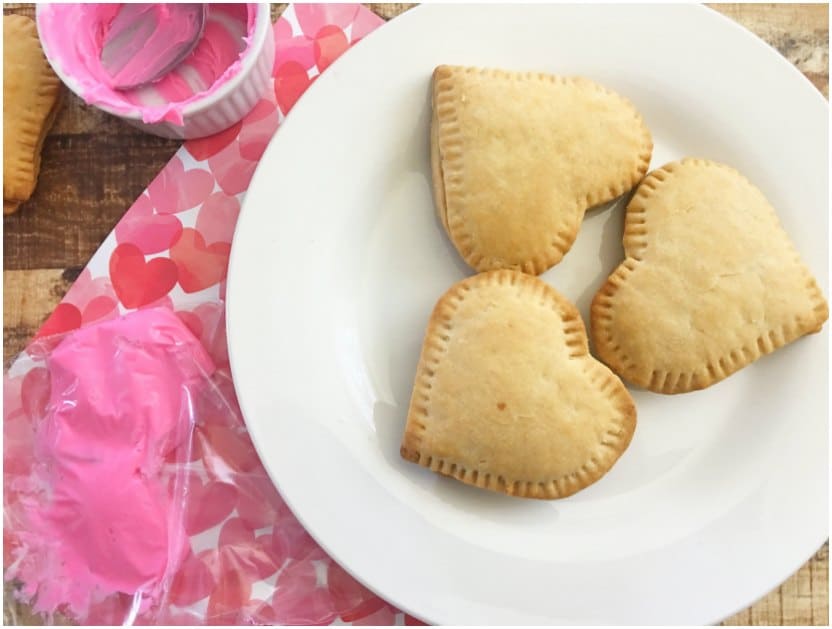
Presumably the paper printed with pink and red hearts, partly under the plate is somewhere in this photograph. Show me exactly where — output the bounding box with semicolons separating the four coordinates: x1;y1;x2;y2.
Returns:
4;4;421;625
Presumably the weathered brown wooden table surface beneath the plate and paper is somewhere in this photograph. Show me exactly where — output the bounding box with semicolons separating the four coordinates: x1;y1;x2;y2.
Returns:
3;4;829;625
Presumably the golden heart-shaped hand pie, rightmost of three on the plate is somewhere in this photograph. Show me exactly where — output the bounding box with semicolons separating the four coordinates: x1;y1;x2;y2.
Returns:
592;159;829;393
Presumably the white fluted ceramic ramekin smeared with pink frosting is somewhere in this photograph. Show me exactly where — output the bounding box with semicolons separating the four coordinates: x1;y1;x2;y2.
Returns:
36;2;274;139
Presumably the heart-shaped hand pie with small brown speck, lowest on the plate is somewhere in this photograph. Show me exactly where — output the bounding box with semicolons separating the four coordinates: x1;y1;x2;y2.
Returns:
401;270;636;498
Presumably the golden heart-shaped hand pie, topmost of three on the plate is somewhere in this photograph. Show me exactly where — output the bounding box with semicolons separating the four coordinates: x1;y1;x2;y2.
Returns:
431;66;653;274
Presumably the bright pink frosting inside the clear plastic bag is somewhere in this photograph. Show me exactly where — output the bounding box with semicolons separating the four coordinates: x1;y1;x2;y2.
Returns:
9;308;214;618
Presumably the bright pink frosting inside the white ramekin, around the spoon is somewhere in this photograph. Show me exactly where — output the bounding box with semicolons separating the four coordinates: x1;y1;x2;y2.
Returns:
37;4;258;125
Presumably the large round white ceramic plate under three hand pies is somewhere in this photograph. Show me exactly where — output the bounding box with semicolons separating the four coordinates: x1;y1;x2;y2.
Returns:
228;5;829;624
